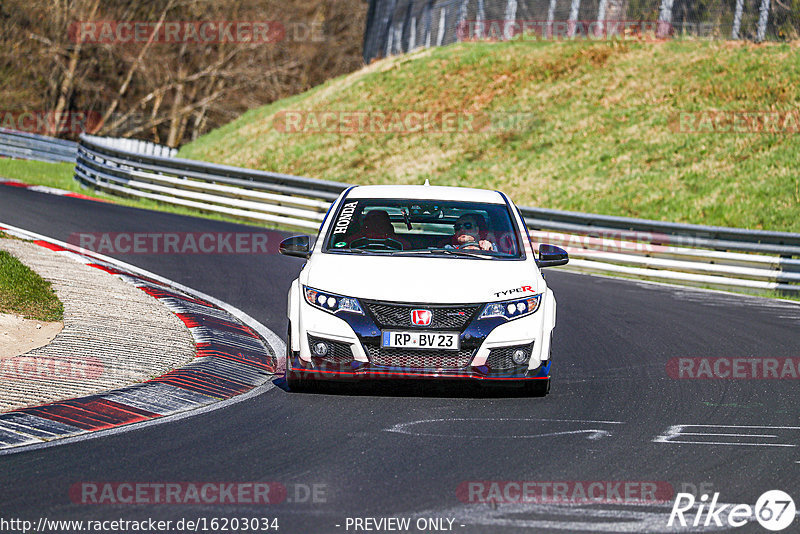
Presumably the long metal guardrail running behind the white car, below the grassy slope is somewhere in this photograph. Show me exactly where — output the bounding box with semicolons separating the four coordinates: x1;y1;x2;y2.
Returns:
0;130;800;294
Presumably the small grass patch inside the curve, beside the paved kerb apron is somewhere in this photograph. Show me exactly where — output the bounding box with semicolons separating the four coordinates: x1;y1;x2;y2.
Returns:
0;248;64;321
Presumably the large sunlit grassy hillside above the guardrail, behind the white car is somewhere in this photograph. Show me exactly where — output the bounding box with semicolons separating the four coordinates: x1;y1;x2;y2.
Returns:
180;40;800;236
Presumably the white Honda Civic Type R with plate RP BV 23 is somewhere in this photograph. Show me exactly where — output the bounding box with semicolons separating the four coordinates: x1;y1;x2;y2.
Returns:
280;185;568;394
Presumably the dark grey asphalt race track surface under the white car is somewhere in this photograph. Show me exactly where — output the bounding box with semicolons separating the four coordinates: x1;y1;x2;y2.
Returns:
0;187;800;533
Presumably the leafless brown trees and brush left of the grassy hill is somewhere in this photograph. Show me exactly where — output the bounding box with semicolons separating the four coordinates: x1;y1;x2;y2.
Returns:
0;0;367;146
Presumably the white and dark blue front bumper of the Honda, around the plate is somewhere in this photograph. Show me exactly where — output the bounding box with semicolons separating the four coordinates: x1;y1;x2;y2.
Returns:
287;302;550;381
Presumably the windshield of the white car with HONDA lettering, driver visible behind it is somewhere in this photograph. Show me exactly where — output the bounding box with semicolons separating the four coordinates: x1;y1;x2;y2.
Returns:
325;198;521;259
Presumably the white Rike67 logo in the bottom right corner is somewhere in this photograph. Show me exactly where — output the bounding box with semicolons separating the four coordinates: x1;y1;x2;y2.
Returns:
667;490;796;531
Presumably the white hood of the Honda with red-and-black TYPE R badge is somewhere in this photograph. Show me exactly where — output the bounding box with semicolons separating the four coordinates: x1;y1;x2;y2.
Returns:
300;253;545;304
